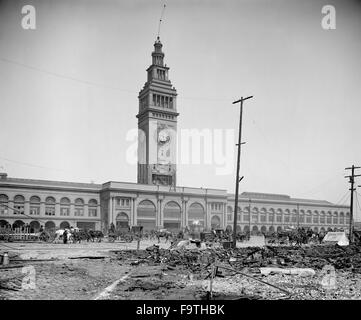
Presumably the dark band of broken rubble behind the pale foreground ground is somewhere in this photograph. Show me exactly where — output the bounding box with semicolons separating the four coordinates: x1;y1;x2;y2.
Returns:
117;245;361;273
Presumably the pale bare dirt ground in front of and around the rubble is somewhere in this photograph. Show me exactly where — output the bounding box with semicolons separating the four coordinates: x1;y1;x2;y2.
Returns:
0;241;361;300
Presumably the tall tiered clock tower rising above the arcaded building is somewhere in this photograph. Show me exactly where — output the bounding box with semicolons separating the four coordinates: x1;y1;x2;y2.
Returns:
137;37;179;186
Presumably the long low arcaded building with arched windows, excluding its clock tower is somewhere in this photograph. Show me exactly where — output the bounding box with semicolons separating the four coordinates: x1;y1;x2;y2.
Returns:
0;174;350;235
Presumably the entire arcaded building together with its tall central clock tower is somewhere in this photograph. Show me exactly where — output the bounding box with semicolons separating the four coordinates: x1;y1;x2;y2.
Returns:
0;38;350;232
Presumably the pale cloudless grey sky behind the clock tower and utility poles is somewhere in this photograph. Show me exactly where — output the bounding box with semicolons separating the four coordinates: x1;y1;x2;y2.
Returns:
0;0;361;204
